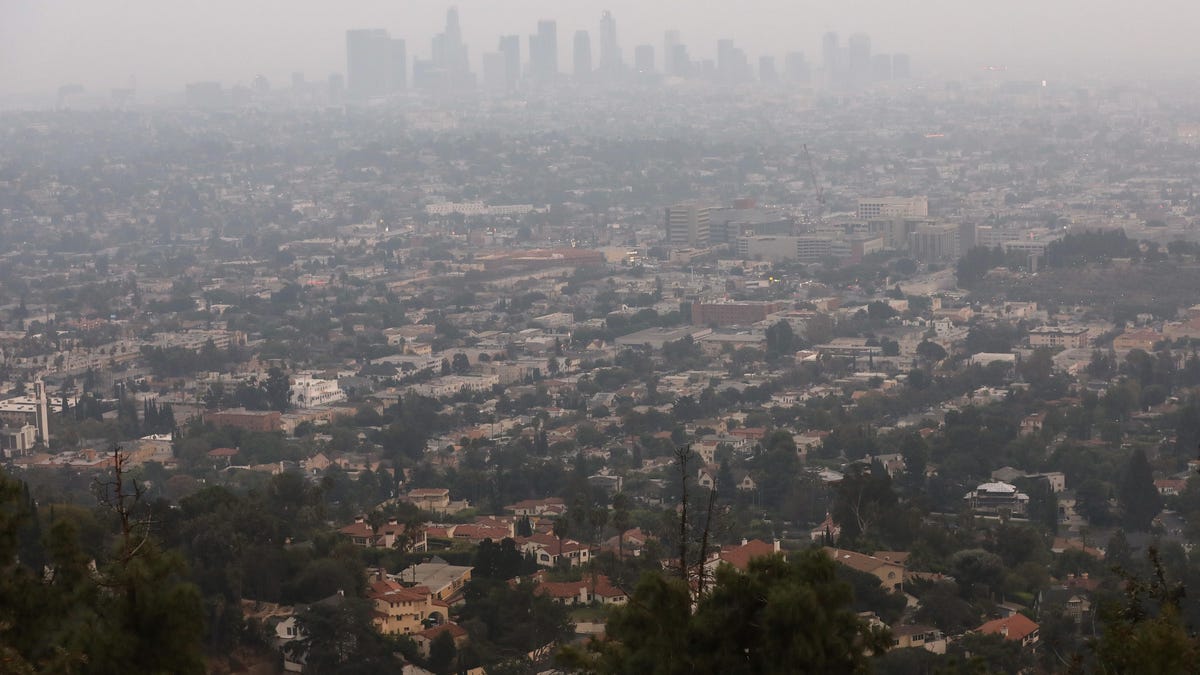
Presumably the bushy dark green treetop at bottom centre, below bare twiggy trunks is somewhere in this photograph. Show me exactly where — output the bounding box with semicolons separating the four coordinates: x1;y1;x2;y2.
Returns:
563;549;890;675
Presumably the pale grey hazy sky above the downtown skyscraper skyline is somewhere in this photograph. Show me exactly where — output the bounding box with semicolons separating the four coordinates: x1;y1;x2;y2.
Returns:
0;0;1200;95
